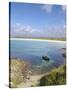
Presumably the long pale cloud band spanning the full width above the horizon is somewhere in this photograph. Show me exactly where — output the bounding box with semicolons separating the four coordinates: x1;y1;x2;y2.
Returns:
11;24;66;37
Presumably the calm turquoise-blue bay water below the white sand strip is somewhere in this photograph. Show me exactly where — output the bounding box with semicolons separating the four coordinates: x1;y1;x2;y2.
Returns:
10;40;65;70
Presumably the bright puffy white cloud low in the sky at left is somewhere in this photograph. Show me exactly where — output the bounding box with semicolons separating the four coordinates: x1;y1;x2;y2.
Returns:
11;23;41;37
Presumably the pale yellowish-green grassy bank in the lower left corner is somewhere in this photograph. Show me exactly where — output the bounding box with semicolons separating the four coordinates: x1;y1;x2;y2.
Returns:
10;59;30;87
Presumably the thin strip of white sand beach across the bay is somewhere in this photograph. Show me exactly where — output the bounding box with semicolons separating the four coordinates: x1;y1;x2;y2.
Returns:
10;38;66;43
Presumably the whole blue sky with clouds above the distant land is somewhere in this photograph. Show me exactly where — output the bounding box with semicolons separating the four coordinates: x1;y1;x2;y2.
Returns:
9;2;66;38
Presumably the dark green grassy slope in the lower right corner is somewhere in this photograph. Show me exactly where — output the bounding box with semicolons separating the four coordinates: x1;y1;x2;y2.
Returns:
39;65;66;86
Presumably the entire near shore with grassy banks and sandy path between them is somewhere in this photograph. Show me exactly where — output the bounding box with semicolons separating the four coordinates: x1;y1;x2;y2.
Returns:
9;59;66;88
